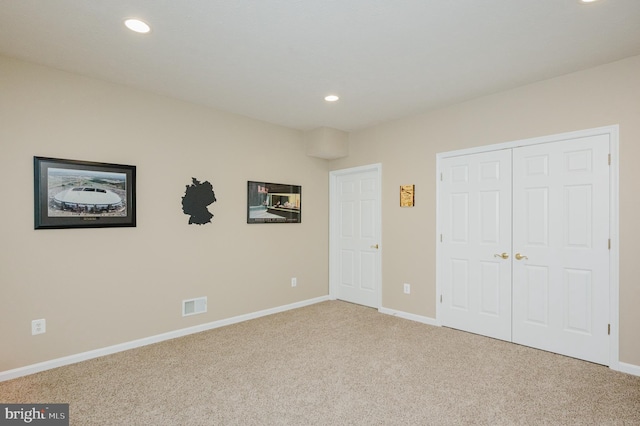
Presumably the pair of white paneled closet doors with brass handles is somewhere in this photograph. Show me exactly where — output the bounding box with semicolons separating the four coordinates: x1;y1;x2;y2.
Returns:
438;135;610;365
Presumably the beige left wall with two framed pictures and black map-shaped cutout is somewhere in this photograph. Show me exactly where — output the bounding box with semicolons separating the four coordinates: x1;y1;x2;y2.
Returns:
0;57;328;371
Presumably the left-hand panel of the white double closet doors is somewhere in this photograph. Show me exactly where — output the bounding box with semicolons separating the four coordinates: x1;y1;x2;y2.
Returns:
439;150;511;340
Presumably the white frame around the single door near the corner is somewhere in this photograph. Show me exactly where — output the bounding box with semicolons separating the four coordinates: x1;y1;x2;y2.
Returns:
329;163;384;310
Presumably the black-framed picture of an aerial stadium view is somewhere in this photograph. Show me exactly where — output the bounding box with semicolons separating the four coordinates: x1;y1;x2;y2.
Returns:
33;157;136;229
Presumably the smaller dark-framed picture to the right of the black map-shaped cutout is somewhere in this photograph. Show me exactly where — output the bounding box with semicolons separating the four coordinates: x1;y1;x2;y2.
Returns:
247;181;302;223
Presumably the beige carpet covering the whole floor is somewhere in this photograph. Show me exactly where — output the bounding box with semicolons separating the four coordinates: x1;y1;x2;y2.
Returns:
0;301;640;426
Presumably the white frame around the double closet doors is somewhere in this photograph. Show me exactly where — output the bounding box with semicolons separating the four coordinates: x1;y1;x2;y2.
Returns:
435;124;620;370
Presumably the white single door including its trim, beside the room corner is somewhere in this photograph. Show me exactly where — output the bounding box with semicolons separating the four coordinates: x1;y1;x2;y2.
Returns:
331;168;380;308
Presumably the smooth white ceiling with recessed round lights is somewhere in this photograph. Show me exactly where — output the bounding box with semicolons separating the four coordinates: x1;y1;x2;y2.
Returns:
0;0;640;131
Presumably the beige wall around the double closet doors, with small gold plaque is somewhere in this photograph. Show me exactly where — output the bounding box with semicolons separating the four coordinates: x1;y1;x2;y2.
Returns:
331;56;640;365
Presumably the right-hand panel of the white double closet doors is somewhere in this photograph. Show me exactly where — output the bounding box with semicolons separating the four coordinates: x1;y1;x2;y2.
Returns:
512;135;609;364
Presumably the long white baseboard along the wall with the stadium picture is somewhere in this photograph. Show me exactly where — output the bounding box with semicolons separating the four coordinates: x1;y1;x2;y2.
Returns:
0;296;330;382
